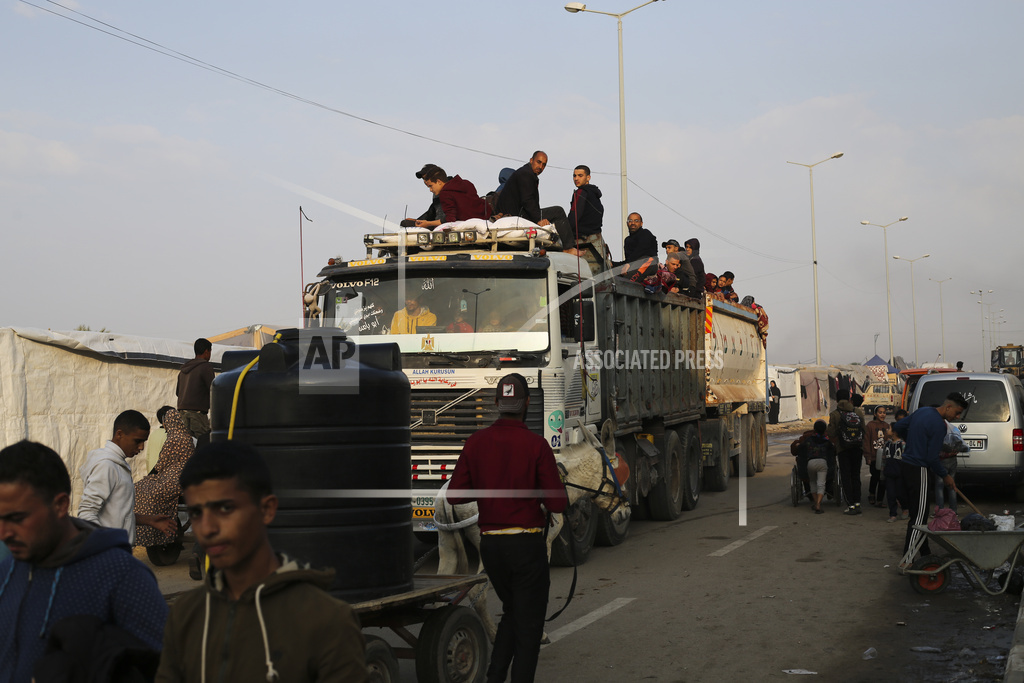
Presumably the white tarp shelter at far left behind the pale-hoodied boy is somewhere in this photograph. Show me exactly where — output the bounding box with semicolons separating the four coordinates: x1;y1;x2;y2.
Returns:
0;328;238;509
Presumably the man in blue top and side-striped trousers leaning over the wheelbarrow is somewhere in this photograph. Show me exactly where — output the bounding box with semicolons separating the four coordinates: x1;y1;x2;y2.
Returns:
893;392;967;564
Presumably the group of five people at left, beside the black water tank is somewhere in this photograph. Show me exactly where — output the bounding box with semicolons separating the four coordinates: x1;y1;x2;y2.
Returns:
0;339;367;683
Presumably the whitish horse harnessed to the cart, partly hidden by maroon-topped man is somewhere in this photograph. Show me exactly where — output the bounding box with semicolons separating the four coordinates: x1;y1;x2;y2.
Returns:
434;429;630;642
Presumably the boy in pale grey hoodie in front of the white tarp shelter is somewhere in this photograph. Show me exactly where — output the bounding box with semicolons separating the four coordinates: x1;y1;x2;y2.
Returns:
78;411;176;545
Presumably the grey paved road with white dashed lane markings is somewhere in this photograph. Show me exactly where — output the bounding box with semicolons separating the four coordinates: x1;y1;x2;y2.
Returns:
148;436;1018;683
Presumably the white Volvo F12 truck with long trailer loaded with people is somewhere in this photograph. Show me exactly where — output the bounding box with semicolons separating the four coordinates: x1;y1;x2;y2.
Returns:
305;224;767;563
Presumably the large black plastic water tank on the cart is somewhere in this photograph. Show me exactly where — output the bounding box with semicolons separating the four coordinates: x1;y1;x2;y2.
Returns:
210;329;413;602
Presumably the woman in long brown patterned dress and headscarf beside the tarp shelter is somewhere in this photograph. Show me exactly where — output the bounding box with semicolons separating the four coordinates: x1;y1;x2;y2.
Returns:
135;410;196;548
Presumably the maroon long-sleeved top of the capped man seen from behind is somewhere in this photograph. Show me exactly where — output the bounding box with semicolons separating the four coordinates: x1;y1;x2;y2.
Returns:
447;419;568;531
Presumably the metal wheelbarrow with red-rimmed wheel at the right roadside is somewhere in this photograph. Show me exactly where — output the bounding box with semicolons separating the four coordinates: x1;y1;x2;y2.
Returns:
901;524;1024;595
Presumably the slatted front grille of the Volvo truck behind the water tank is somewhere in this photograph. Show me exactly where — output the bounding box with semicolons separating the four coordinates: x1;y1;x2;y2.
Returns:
410;387;544;487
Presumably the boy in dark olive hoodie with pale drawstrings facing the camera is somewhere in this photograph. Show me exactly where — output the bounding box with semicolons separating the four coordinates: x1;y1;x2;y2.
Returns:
157;441;367;683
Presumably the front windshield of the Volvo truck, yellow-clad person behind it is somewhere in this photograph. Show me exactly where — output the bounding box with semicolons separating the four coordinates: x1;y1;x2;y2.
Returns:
308;270;549;353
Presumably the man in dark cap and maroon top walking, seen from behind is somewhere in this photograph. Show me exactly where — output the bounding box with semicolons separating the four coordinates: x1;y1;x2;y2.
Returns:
447;373;568;683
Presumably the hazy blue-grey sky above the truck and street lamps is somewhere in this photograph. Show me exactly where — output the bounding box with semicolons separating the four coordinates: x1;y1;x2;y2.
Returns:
0;0;1024;369
